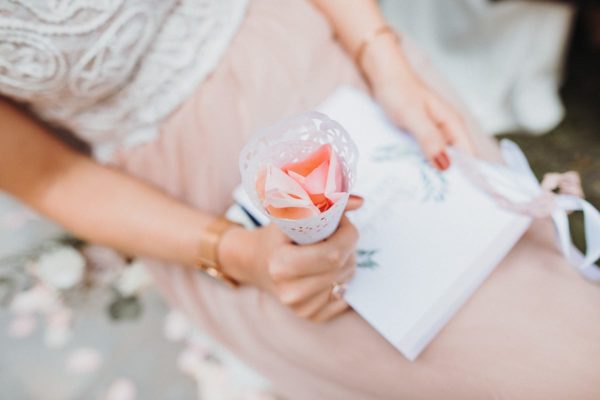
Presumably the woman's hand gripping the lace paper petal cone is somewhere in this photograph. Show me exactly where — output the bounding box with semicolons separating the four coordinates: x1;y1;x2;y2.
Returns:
219;196;362;322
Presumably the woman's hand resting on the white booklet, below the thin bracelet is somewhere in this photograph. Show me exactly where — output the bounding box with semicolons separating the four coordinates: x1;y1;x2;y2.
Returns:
361;35;473;170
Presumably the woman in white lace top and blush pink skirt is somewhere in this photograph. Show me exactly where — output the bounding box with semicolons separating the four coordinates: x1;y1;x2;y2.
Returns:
0;0;600;399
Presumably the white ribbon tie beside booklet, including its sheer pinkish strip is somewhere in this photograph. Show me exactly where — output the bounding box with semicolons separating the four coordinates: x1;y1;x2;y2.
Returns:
455;139;600;281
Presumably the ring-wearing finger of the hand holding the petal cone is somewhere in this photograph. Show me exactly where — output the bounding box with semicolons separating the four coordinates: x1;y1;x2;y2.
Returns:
277;259;356;306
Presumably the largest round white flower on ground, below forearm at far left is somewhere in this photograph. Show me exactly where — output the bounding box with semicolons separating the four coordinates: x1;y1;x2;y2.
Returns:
33;246;85;289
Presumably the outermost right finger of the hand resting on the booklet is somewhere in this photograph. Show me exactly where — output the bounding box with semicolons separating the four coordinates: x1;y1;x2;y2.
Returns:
430;99;474;154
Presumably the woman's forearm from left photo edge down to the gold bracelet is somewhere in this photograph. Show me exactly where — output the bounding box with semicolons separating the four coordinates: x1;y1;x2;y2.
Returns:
0;100;212;265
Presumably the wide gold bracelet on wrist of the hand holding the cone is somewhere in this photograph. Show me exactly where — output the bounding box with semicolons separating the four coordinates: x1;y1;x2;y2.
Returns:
196;218;239;287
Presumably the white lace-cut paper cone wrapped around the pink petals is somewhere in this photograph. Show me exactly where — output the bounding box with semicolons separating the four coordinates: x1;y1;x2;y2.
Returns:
240;112;358;244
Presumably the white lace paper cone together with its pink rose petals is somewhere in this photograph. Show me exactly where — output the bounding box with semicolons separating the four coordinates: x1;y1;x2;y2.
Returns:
240;112;358;244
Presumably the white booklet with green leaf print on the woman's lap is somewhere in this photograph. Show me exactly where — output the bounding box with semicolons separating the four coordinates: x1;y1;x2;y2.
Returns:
228;87;530;360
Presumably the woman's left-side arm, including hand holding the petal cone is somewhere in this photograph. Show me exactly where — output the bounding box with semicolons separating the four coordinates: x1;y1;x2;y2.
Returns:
0;99;361;321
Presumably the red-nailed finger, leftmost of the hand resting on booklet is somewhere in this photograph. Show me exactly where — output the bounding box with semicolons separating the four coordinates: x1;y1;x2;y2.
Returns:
406;110;446;169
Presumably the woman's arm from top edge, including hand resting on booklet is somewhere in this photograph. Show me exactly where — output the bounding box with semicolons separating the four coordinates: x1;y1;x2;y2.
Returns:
313;0;472;169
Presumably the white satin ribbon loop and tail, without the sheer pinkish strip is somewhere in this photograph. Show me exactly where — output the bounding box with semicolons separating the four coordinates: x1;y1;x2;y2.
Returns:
500;139;600;281
